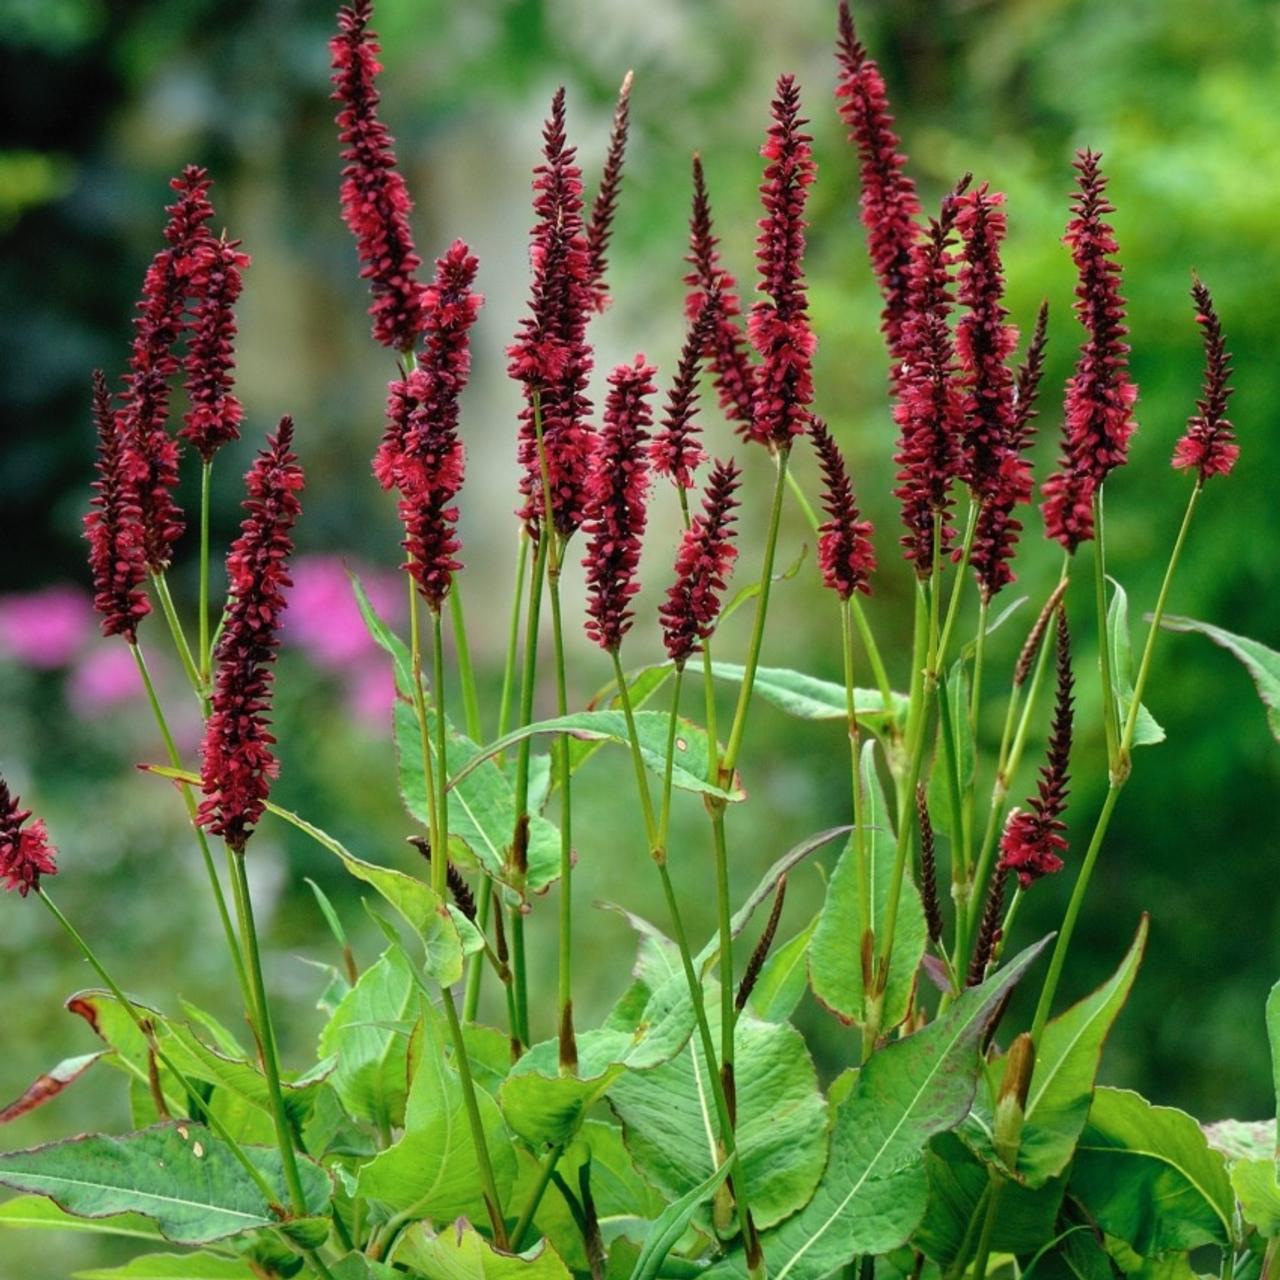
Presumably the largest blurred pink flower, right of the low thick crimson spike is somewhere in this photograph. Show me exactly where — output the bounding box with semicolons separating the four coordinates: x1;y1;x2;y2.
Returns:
284;556;404;672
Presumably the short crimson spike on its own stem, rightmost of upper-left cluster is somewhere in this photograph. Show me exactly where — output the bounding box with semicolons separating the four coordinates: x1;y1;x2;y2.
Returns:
178;238;250;462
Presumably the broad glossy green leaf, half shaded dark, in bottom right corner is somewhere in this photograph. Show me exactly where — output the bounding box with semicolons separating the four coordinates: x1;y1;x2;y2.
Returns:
1070;1088;1235;1257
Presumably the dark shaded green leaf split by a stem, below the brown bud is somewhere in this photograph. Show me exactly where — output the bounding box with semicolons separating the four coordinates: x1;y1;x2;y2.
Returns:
911;1133;1066;1270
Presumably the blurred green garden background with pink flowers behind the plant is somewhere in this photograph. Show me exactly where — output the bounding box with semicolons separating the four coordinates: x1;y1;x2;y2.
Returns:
0;0;1280;1276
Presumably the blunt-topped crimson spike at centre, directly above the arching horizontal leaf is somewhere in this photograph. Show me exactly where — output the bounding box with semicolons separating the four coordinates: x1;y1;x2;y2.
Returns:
582;356;657;653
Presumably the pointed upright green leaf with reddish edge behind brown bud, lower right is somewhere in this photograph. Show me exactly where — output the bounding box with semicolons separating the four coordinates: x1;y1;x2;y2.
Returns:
966;915;1147;1187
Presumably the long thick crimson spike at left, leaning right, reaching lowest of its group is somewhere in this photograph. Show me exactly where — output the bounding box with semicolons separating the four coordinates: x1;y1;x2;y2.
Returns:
198;417;303;854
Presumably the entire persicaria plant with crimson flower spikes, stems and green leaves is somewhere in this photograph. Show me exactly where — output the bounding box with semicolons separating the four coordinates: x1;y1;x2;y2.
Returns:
0;0;1280;1280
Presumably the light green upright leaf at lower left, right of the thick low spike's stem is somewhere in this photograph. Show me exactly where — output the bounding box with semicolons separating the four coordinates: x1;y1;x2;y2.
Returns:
320;947;420;1129
